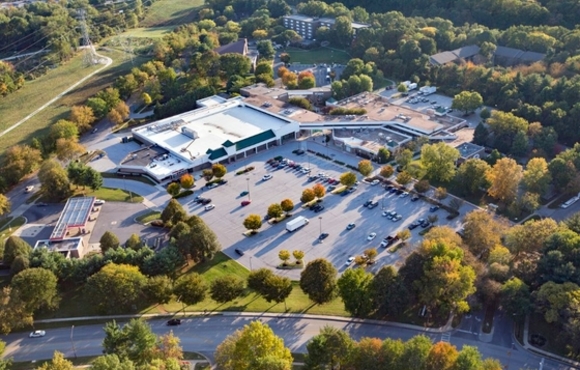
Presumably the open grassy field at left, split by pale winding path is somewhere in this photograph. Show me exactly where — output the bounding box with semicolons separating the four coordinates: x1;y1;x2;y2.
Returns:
0;50;148;154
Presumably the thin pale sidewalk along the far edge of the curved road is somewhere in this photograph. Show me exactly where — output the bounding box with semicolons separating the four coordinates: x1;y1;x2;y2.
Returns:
34;312;453;333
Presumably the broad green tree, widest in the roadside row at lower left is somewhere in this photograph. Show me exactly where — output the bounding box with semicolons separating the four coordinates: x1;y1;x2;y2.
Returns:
84;263;147;314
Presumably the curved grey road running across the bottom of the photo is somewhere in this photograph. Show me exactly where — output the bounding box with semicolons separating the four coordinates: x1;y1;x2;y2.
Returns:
2;314;573;370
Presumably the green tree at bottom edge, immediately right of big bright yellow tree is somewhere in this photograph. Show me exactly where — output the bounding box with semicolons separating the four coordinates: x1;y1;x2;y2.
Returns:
304;326;354;369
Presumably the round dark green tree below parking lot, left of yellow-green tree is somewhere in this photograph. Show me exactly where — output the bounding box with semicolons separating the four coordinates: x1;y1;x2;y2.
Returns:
300;258;336;304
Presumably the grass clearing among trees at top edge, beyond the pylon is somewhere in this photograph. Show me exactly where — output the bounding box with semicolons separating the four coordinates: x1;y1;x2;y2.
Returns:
140;0;204;27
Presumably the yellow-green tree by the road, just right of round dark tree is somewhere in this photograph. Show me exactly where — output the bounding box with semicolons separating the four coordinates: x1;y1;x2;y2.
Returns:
337;268;373;317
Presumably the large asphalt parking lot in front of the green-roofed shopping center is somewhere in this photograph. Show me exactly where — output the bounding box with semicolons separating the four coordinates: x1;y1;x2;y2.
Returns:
183;142;473;279
